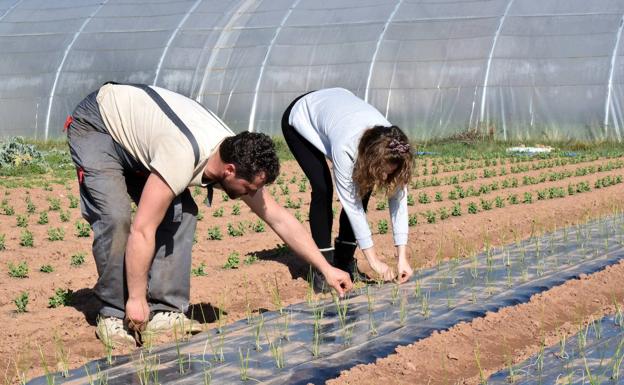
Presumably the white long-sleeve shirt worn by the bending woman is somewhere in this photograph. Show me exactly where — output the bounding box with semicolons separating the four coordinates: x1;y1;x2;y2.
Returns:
288;88;408;249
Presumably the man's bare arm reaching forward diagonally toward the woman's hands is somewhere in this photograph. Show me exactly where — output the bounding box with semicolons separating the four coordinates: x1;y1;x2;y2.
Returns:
241;188;353;296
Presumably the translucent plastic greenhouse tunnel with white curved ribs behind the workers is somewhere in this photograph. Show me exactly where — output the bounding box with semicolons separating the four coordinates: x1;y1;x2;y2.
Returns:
0;0;624;141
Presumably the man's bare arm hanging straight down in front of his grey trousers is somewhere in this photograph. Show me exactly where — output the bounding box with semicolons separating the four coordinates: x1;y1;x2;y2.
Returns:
125;172;175;330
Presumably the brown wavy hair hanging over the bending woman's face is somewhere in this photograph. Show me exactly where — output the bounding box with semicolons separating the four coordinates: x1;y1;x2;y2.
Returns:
353;126;414;198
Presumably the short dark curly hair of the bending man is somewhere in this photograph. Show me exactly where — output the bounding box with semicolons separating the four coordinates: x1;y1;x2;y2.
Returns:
219;131;279;184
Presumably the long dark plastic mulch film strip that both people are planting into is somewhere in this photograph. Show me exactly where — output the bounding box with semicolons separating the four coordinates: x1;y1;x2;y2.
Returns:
32;215;624;384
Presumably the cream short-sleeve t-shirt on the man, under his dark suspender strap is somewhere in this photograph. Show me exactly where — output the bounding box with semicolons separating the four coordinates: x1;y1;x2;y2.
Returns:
97;84;234;195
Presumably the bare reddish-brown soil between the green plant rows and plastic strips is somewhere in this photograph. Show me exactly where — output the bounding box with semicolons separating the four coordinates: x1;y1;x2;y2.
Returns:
0;155;624;384
